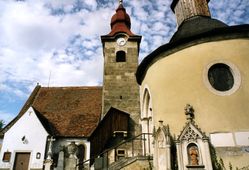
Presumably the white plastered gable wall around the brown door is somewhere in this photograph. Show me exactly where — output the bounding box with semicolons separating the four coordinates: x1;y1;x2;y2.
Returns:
0;108;48;169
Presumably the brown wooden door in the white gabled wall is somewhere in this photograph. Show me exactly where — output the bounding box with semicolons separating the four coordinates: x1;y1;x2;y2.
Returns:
13;153;30;170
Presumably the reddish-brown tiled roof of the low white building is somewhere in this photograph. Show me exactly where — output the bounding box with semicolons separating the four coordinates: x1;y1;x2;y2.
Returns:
0;87;102;137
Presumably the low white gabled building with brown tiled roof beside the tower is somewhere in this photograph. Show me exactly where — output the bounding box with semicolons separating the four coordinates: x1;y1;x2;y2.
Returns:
0;85;102;170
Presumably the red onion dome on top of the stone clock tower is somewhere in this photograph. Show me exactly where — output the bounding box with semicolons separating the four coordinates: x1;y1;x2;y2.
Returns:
108;3;133;36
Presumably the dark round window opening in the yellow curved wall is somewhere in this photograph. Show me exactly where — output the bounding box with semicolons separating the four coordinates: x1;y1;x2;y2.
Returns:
208;63;234;92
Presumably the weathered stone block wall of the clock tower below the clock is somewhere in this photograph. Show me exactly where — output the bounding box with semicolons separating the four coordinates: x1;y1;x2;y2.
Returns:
103;40;141;135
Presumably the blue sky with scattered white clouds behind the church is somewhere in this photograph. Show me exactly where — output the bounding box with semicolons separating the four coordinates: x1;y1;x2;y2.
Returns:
0;0;249;124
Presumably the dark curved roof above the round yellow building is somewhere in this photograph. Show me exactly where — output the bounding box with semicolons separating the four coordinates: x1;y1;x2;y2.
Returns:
136;24;249;85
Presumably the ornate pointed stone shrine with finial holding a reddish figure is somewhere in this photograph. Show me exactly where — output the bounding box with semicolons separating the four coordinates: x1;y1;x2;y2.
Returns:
176;104;213;170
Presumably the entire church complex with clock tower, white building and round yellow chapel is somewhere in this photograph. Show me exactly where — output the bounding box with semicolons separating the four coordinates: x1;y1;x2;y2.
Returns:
0;0;249;170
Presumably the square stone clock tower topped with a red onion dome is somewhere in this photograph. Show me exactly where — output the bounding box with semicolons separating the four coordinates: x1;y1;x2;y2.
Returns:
101;0;141;135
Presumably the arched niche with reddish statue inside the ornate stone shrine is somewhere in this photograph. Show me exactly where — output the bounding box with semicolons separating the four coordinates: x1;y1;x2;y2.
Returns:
187;143;200;165
